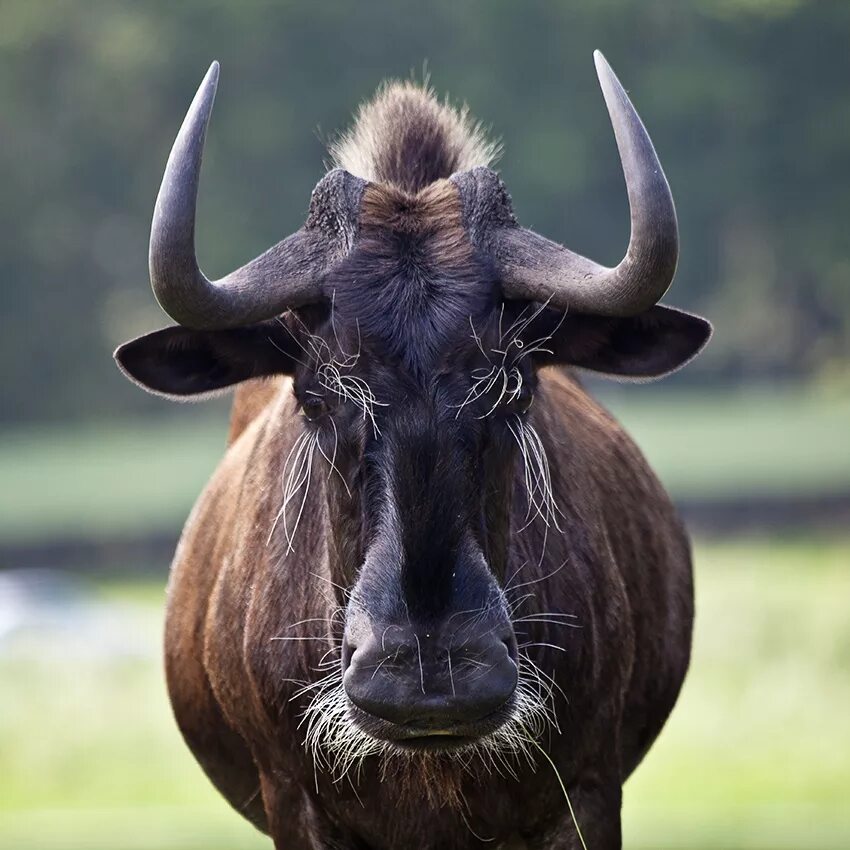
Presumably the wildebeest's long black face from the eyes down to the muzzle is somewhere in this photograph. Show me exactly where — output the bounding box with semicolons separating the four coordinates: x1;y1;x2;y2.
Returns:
280;294;542;748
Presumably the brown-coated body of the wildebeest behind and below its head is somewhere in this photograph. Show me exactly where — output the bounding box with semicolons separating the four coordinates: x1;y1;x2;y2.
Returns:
165;369;693;850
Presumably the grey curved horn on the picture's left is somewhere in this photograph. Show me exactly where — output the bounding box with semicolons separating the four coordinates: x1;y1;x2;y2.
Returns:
149;62;359;330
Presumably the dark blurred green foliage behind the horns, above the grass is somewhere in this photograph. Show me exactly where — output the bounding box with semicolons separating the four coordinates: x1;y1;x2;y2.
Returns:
0;0;850;422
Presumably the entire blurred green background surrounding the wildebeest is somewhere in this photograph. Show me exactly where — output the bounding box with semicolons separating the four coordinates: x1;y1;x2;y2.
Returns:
0;0;850;850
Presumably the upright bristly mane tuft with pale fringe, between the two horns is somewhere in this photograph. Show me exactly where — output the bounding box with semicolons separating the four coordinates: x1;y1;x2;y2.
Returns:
330;81;499;195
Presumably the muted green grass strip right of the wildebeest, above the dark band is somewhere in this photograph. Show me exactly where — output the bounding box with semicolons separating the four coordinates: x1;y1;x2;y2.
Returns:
605;386;850;497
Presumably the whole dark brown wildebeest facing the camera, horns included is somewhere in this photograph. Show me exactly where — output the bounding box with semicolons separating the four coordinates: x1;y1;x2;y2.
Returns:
116;53;710;850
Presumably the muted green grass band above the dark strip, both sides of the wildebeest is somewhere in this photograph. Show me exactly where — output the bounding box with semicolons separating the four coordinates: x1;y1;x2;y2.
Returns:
0;387;850;542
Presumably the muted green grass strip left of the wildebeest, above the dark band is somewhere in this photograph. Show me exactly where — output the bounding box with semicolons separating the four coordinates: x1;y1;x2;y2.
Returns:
0;408;227;542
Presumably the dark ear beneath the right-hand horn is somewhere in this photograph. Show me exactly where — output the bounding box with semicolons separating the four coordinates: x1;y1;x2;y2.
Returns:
532;304;712;380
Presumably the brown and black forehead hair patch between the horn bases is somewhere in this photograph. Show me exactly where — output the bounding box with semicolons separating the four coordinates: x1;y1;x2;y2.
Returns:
330;180;495;379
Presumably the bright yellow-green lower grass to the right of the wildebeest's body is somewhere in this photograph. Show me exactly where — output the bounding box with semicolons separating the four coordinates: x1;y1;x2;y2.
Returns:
625;541;850;850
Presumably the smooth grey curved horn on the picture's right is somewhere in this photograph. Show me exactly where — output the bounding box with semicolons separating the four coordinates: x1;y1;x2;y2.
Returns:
490;50;679;316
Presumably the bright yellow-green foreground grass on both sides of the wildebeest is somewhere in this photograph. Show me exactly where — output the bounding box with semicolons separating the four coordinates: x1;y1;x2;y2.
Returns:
0;538;850;850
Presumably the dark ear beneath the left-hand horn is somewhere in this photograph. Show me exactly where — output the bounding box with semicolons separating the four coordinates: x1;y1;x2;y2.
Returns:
114;321;298;401
